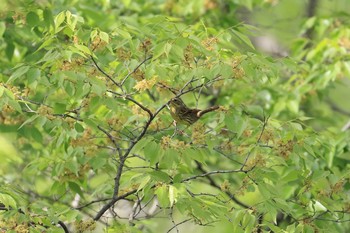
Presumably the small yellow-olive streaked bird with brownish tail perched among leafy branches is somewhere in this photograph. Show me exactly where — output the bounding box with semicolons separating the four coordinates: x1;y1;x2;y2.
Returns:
169;98;219;126
